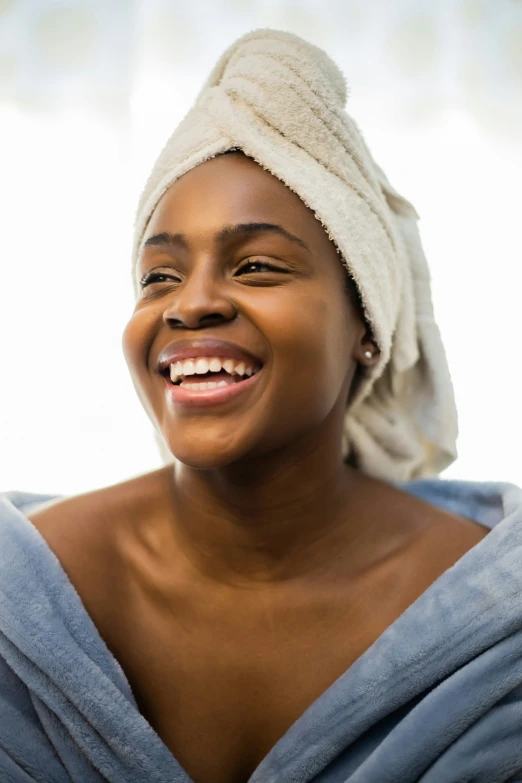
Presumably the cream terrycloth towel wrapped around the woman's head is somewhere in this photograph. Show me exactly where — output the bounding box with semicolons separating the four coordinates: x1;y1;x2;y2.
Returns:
133;30;457;481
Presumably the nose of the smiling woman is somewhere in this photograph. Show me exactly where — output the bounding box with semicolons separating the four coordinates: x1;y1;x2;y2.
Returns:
163;270;236;329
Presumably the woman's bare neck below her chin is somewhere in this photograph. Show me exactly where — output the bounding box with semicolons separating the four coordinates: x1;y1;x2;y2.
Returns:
158;440;369;587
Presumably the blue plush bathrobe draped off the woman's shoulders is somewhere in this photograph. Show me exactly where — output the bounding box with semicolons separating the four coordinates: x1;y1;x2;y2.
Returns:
0;480;522;783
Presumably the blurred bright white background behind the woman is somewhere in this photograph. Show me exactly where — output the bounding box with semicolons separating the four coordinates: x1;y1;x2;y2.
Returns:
0;0;522;494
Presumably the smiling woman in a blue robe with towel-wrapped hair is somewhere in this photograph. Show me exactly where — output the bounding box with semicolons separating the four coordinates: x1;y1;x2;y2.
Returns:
0;30;522;783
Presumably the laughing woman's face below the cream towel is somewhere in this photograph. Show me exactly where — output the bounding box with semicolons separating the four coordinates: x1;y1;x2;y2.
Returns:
122;154;368;469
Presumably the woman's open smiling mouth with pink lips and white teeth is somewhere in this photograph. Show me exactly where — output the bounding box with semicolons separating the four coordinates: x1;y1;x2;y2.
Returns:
158;357;262;406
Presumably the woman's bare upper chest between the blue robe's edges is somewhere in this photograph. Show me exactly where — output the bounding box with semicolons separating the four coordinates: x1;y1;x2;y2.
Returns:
92;536;468;783
